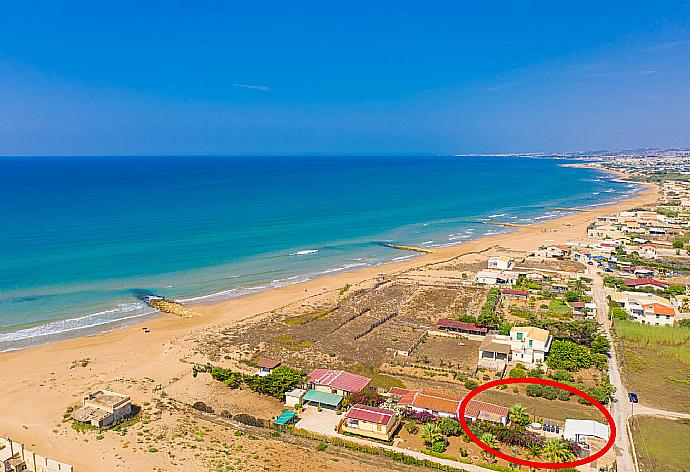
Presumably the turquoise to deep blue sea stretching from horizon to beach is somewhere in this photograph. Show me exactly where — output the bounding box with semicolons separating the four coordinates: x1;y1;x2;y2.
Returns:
0;156;637;350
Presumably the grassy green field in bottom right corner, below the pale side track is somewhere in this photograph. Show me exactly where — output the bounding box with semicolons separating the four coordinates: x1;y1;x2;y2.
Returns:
632;416;690;472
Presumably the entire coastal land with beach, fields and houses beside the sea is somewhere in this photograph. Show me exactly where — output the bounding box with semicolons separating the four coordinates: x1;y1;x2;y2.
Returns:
0;149;690;472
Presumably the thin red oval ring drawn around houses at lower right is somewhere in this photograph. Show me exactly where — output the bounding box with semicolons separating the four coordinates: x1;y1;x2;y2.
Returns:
458;377;616;469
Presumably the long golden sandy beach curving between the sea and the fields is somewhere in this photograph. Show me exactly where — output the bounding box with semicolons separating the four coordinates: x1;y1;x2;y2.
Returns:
0;178;657;471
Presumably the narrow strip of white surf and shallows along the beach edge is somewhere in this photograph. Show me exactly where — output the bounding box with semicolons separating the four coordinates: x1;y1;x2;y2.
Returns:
0;163;646;355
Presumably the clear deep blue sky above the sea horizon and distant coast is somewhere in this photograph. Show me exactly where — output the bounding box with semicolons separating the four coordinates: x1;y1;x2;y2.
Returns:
0;0;690;155
